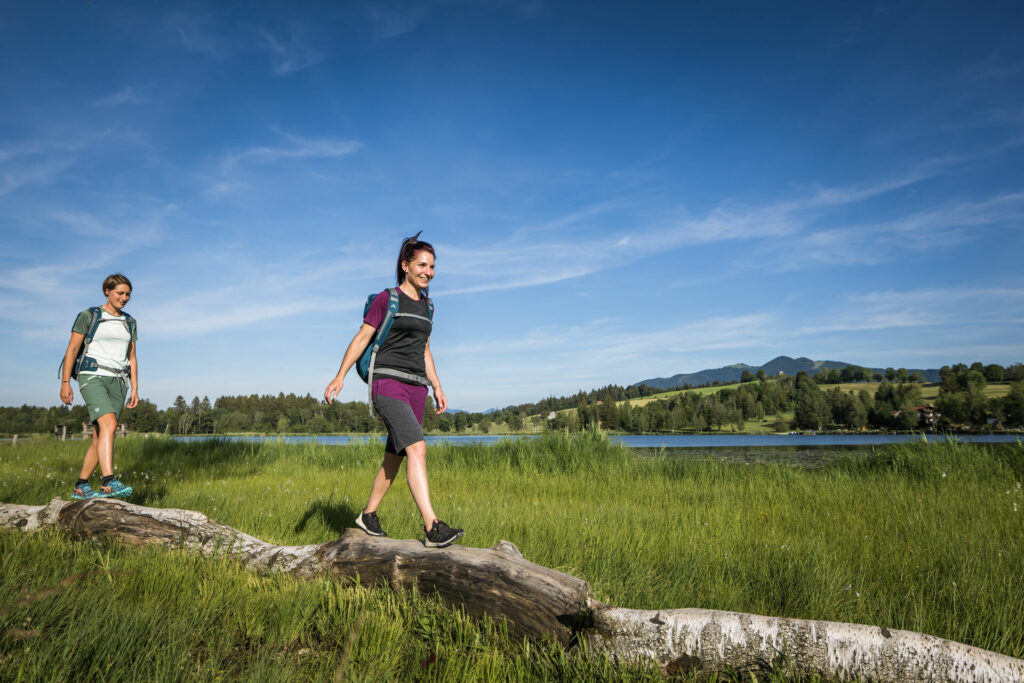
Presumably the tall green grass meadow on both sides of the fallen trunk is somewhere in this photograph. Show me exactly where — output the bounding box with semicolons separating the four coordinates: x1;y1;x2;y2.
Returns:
0;433;1024;680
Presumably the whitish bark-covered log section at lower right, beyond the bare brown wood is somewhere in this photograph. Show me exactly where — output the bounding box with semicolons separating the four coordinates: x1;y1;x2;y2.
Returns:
586;607;1024;683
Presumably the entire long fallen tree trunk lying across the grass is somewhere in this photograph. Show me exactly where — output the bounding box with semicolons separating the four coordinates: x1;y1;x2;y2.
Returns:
0;499;1024;681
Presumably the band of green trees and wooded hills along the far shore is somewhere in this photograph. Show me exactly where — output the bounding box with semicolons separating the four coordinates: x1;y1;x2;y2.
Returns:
0;362;1024;435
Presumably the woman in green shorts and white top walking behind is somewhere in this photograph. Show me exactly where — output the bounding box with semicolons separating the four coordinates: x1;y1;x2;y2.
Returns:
60;272;138;501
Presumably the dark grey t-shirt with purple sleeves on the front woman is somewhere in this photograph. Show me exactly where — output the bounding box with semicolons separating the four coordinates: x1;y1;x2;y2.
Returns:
362;288;433;377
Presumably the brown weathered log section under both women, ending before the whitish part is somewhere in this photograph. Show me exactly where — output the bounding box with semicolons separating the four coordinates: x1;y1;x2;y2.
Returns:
0;499;590;644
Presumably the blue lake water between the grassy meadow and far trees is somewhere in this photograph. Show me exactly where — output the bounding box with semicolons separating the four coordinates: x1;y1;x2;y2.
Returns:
172;434;1021;468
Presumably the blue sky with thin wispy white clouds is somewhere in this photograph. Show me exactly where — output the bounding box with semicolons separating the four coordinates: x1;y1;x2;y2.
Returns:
0;0;1024;411
